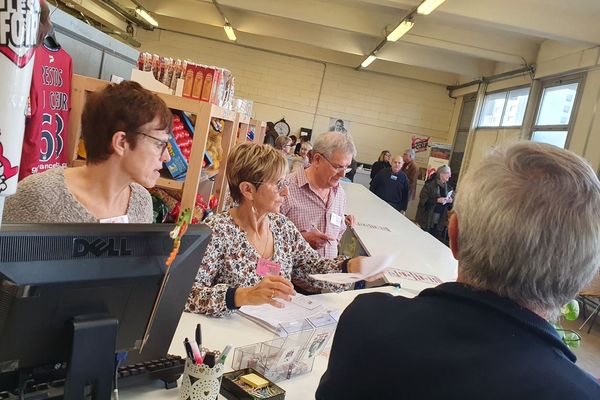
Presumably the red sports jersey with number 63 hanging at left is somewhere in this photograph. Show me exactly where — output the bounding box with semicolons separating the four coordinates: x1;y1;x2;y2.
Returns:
19;45;73;180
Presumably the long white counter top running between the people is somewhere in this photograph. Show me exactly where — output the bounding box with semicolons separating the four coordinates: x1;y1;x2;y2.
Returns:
121;184;457;400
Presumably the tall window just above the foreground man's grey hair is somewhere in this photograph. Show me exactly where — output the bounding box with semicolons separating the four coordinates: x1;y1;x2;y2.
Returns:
531;81;579;148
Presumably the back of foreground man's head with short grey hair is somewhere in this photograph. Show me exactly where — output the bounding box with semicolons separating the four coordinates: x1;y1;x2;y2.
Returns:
454;142;600;317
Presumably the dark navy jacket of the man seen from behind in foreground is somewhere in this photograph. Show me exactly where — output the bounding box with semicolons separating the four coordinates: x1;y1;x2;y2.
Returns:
316;283;600;400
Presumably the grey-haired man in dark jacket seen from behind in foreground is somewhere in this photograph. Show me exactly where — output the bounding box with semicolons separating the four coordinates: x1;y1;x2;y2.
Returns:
316;142;600;400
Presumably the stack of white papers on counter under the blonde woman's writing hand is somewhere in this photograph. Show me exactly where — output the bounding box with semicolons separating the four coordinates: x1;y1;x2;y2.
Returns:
239;293;328;332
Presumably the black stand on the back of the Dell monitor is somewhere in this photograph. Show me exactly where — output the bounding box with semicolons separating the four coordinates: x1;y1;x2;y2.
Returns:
64;316;118;400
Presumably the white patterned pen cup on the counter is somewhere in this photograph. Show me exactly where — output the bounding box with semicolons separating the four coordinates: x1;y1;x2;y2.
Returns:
179;358;225;400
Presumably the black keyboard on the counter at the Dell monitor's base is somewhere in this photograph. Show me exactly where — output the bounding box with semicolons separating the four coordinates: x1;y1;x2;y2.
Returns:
0;355;185;400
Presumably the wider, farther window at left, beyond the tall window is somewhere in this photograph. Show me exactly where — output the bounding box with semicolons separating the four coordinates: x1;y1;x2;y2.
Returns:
478;87;529;128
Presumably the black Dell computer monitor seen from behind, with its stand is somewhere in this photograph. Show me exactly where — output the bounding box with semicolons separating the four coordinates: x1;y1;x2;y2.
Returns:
0;224;210;398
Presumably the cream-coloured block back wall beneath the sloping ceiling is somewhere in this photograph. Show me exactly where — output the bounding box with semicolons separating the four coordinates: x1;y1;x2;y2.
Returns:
136;30;456;162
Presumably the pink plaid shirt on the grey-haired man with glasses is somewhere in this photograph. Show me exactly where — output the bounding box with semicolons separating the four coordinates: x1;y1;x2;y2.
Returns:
281;168;346;258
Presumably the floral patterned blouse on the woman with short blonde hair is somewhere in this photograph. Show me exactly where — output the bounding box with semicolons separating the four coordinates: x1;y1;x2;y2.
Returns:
185;211;347;316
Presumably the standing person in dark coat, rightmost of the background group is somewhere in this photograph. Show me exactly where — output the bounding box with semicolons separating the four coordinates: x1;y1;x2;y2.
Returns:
416;165;453;239
